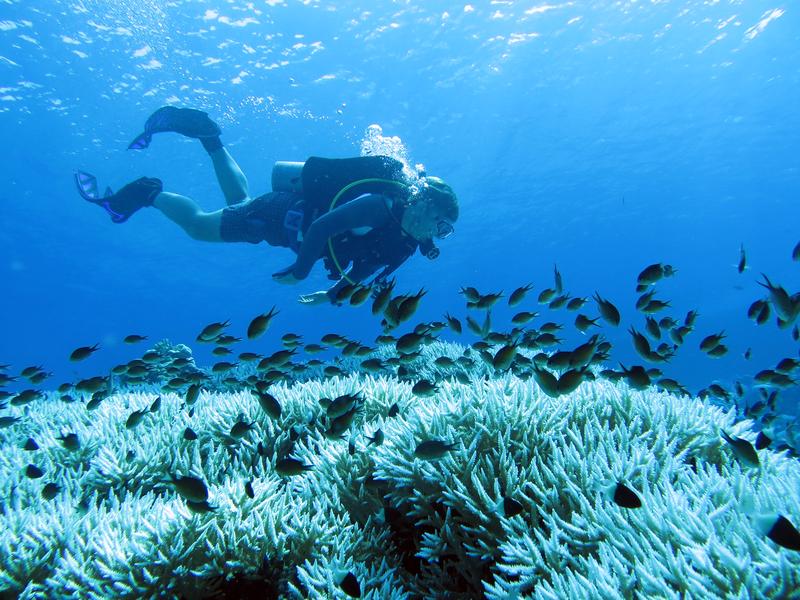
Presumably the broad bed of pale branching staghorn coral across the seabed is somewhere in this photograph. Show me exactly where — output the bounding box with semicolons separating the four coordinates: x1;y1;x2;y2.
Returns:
0;343;800;599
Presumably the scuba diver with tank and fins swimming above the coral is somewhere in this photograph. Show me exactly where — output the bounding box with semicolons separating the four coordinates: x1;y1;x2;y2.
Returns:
75;106;458;304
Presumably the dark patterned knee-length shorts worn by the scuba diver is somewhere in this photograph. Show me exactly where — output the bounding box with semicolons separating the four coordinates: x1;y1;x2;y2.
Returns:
219;192;303;248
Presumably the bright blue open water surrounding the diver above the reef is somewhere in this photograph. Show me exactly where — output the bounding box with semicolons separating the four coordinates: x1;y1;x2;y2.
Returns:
0;0;800;406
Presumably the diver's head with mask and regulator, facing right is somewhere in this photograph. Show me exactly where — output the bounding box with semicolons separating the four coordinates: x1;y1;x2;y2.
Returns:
401;177;458;258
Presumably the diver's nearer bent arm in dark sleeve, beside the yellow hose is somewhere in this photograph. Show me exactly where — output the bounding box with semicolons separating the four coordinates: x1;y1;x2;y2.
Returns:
291;194;390;279
